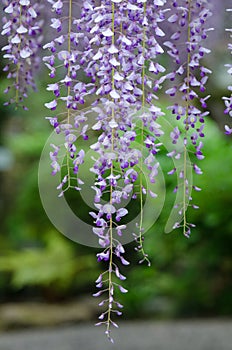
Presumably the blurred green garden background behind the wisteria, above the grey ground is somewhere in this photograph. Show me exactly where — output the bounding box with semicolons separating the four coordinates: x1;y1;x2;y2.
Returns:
0;1;232;329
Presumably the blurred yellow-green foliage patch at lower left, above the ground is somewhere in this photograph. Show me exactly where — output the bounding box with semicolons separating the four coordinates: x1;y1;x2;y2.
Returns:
0;231;96;297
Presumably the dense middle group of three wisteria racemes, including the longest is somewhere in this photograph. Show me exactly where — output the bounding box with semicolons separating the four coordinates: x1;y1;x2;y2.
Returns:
44;0;167;338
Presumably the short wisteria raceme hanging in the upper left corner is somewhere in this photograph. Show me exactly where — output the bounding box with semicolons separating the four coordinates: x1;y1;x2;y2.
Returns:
1;0;43;109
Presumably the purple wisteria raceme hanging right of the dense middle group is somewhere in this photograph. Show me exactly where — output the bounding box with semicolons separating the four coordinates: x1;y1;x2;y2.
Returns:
164;0;212;237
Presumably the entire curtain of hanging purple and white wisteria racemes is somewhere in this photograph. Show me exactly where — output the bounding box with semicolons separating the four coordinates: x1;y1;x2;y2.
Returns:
2;0;232;341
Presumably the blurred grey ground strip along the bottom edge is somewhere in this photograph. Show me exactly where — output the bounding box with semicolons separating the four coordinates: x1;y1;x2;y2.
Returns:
0;320;232;350
